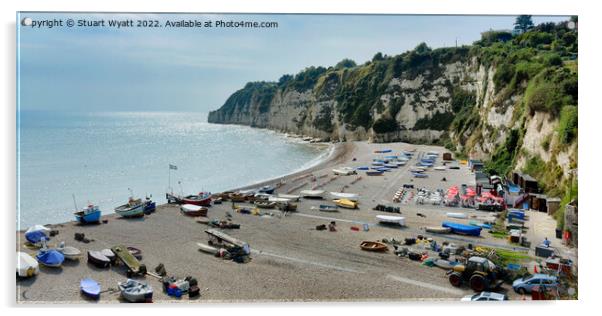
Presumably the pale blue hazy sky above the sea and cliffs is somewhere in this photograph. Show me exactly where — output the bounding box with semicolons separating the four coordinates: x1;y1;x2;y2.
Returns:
17;13;568;112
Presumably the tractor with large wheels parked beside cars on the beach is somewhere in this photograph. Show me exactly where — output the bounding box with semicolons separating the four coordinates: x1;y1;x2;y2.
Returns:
447;256;504;292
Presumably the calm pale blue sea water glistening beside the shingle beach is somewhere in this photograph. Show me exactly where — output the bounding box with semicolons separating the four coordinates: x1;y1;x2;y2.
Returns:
17;112;328;229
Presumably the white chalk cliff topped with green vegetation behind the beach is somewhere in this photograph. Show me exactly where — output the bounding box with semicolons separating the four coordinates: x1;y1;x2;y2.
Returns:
209;24;577;195
